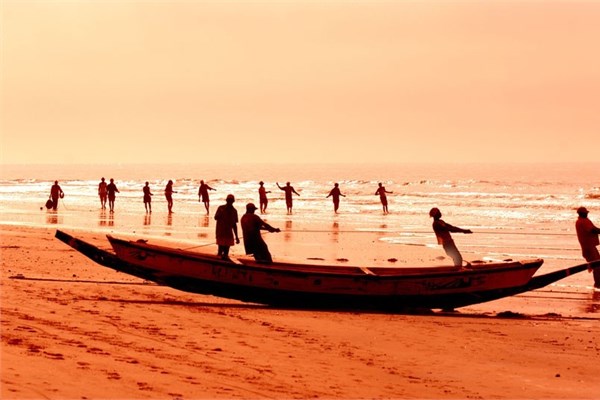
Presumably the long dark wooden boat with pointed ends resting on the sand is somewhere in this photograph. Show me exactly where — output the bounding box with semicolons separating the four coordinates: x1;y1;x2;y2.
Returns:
56;231;600;310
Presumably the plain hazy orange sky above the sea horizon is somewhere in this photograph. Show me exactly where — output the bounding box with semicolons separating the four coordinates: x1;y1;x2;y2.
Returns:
0;0;600;163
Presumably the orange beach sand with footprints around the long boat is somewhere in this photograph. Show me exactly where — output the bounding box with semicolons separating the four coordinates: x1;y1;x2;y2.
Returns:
0;227;600;399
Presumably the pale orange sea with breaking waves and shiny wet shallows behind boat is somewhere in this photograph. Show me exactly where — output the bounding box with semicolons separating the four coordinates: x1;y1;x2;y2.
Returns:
0;163;600;296
